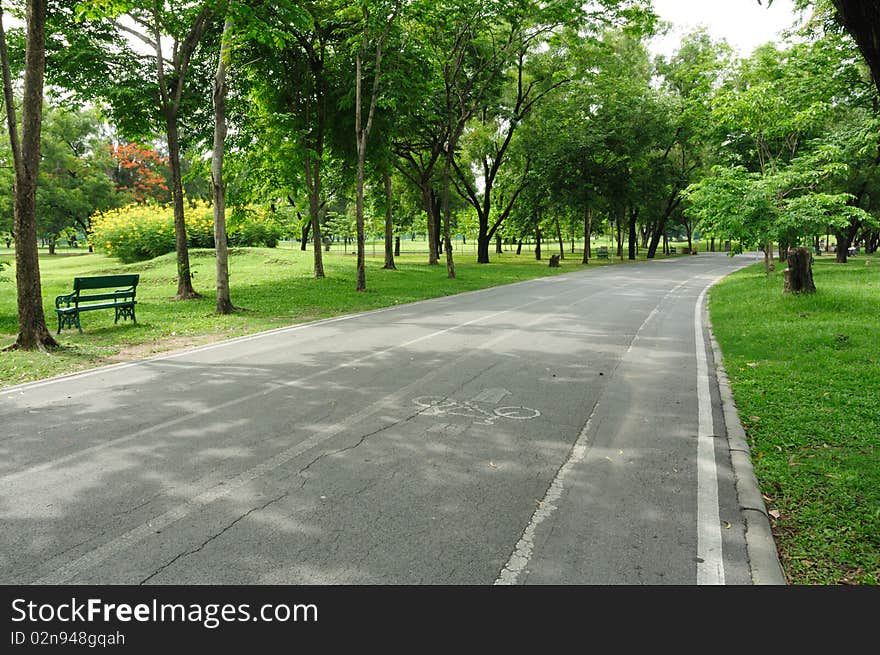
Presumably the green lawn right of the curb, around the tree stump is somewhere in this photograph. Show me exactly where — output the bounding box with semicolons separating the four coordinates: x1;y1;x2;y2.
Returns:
710;256;880;585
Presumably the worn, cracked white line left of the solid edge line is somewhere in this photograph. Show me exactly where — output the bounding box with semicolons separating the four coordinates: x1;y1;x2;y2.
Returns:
495;279;691;585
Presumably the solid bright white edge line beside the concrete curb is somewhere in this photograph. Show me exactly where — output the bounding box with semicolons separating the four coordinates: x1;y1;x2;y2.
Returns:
694;280;724;585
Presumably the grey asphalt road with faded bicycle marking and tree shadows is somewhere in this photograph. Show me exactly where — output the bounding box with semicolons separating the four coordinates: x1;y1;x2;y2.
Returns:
0;253;754;585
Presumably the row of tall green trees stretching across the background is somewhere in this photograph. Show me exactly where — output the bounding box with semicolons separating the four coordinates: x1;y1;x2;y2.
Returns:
0;0;880;348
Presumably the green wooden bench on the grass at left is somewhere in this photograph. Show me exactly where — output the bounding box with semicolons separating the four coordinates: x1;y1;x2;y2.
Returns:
55;275;140;334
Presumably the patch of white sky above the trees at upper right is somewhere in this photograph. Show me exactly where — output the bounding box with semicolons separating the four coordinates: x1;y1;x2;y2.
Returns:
651;0;798;57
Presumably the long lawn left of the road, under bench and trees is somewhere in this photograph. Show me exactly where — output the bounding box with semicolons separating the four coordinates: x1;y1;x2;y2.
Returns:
0;243;672;388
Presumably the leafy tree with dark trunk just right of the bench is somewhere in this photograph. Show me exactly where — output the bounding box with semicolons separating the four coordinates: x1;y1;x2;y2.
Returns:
50;0;224;299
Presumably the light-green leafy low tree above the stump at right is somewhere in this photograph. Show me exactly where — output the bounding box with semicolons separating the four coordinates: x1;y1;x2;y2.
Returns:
687;35;880;273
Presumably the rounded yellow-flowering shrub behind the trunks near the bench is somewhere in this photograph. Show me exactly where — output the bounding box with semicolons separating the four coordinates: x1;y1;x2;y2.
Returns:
89;201;281;263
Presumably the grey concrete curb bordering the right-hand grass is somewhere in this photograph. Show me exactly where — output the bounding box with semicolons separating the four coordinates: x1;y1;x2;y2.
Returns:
706;321;788;585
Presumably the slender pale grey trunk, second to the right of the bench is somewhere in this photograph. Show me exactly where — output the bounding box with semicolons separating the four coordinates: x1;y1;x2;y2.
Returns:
211;16;234;314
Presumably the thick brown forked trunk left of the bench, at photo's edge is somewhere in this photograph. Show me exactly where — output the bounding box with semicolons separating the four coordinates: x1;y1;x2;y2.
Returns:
0;0;58;350
